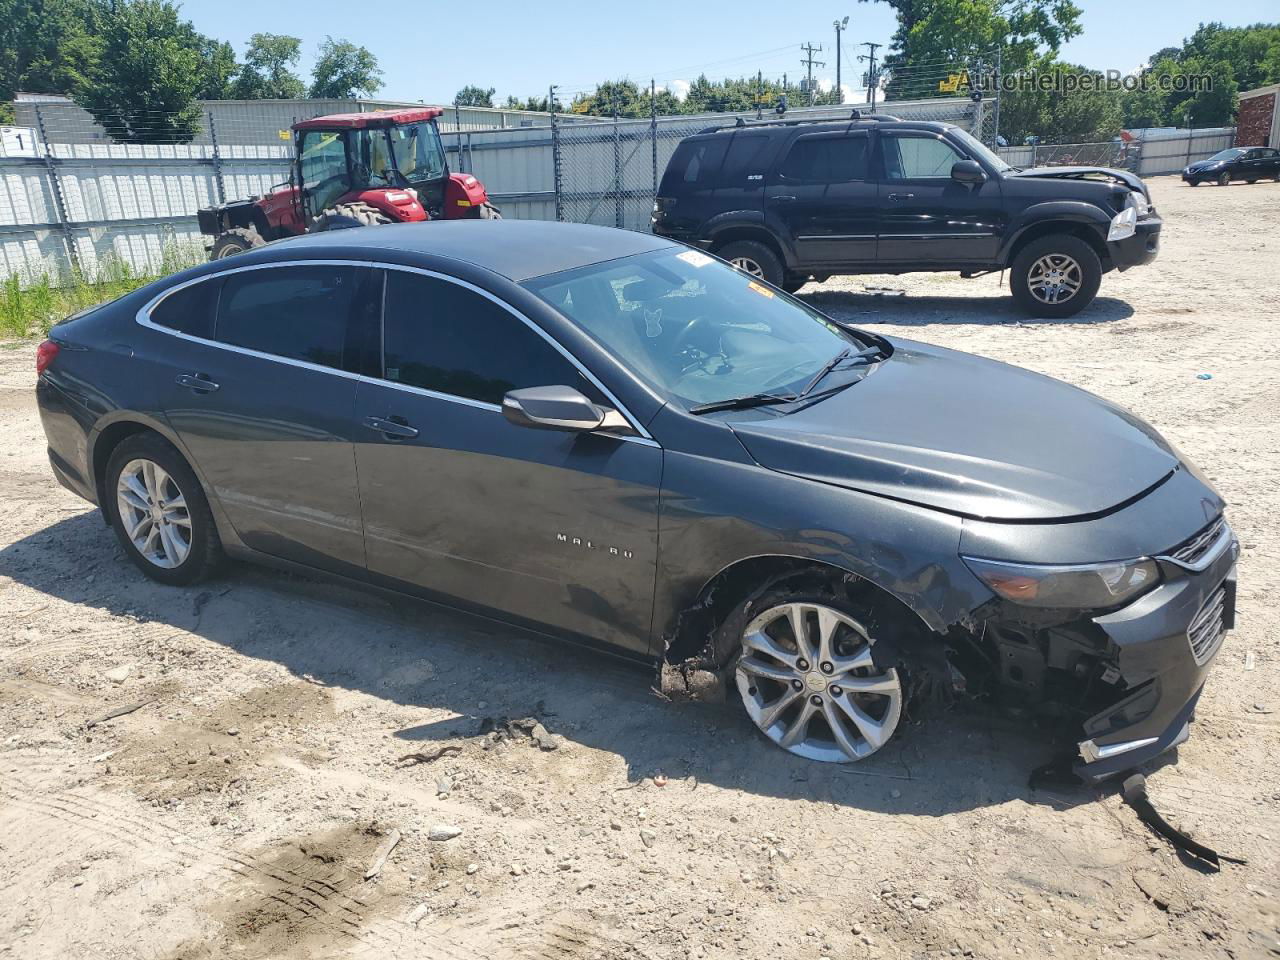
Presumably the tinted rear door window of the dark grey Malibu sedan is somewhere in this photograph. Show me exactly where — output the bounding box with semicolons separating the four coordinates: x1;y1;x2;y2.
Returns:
215;265;380;369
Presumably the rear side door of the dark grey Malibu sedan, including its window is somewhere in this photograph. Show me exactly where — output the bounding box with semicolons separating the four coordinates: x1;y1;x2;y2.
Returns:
143;264;381;572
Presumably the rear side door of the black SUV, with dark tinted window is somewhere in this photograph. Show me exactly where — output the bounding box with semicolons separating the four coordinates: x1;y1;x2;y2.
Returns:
767;131;877;268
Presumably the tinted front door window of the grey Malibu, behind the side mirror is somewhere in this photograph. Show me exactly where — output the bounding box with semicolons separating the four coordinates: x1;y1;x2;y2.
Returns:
383;270;603;404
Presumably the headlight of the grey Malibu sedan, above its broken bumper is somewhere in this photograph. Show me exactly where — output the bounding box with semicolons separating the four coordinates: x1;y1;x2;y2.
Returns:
961;557;1160;611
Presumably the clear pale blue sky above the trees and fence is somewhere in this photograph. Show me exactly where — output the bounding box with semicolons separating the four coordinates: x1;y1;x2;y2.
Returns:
182;0;1276;102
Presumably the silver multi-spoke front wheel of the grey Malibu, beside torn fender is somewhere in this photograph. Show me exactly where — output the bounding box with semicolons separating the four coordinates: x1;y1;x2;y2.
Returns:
736;602;902;763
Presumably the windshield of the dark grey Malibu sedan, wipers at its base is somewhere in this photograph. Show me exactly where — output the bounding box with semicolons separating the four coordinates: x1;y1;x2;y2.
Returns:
524;250;865;406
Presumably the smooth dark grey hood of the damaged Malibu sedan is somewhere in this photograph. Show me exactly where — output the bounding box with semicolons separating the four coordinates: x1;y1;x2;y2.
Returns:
731;339;1178;521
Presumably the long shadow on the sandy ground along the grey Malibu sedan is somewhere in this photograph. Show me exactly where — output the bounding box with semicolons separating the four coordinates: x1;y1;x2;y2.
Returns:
0;511;1116;817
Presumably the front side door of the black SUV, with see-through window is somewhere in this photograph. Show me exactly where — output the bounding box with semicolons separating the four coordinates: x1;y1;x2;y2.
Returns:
877;131;1005;268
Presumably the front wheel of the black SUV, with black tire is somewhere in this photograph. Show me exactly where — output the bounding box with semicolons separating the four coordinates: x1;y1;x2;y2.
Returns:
1009;233;1102;317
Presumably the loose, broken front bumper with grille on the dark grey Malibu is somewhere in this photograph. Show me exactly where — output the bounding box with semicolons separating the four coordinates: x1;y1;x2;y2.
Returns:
1075;522;1239;780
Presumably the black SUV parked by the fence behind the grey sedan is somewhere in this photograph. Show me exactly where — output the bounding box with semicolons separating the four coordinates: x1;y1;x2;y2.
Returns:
653;111;1161;317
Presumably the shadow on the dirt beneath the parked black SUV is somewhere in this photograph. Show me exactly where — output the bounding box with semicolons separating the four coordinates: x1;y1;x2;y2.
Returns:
797;289;1134;326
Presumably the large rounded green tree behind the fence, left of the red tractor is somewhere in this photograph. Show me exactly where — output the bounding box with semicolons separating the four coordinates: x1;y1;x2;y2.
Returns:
73;0;201;143
